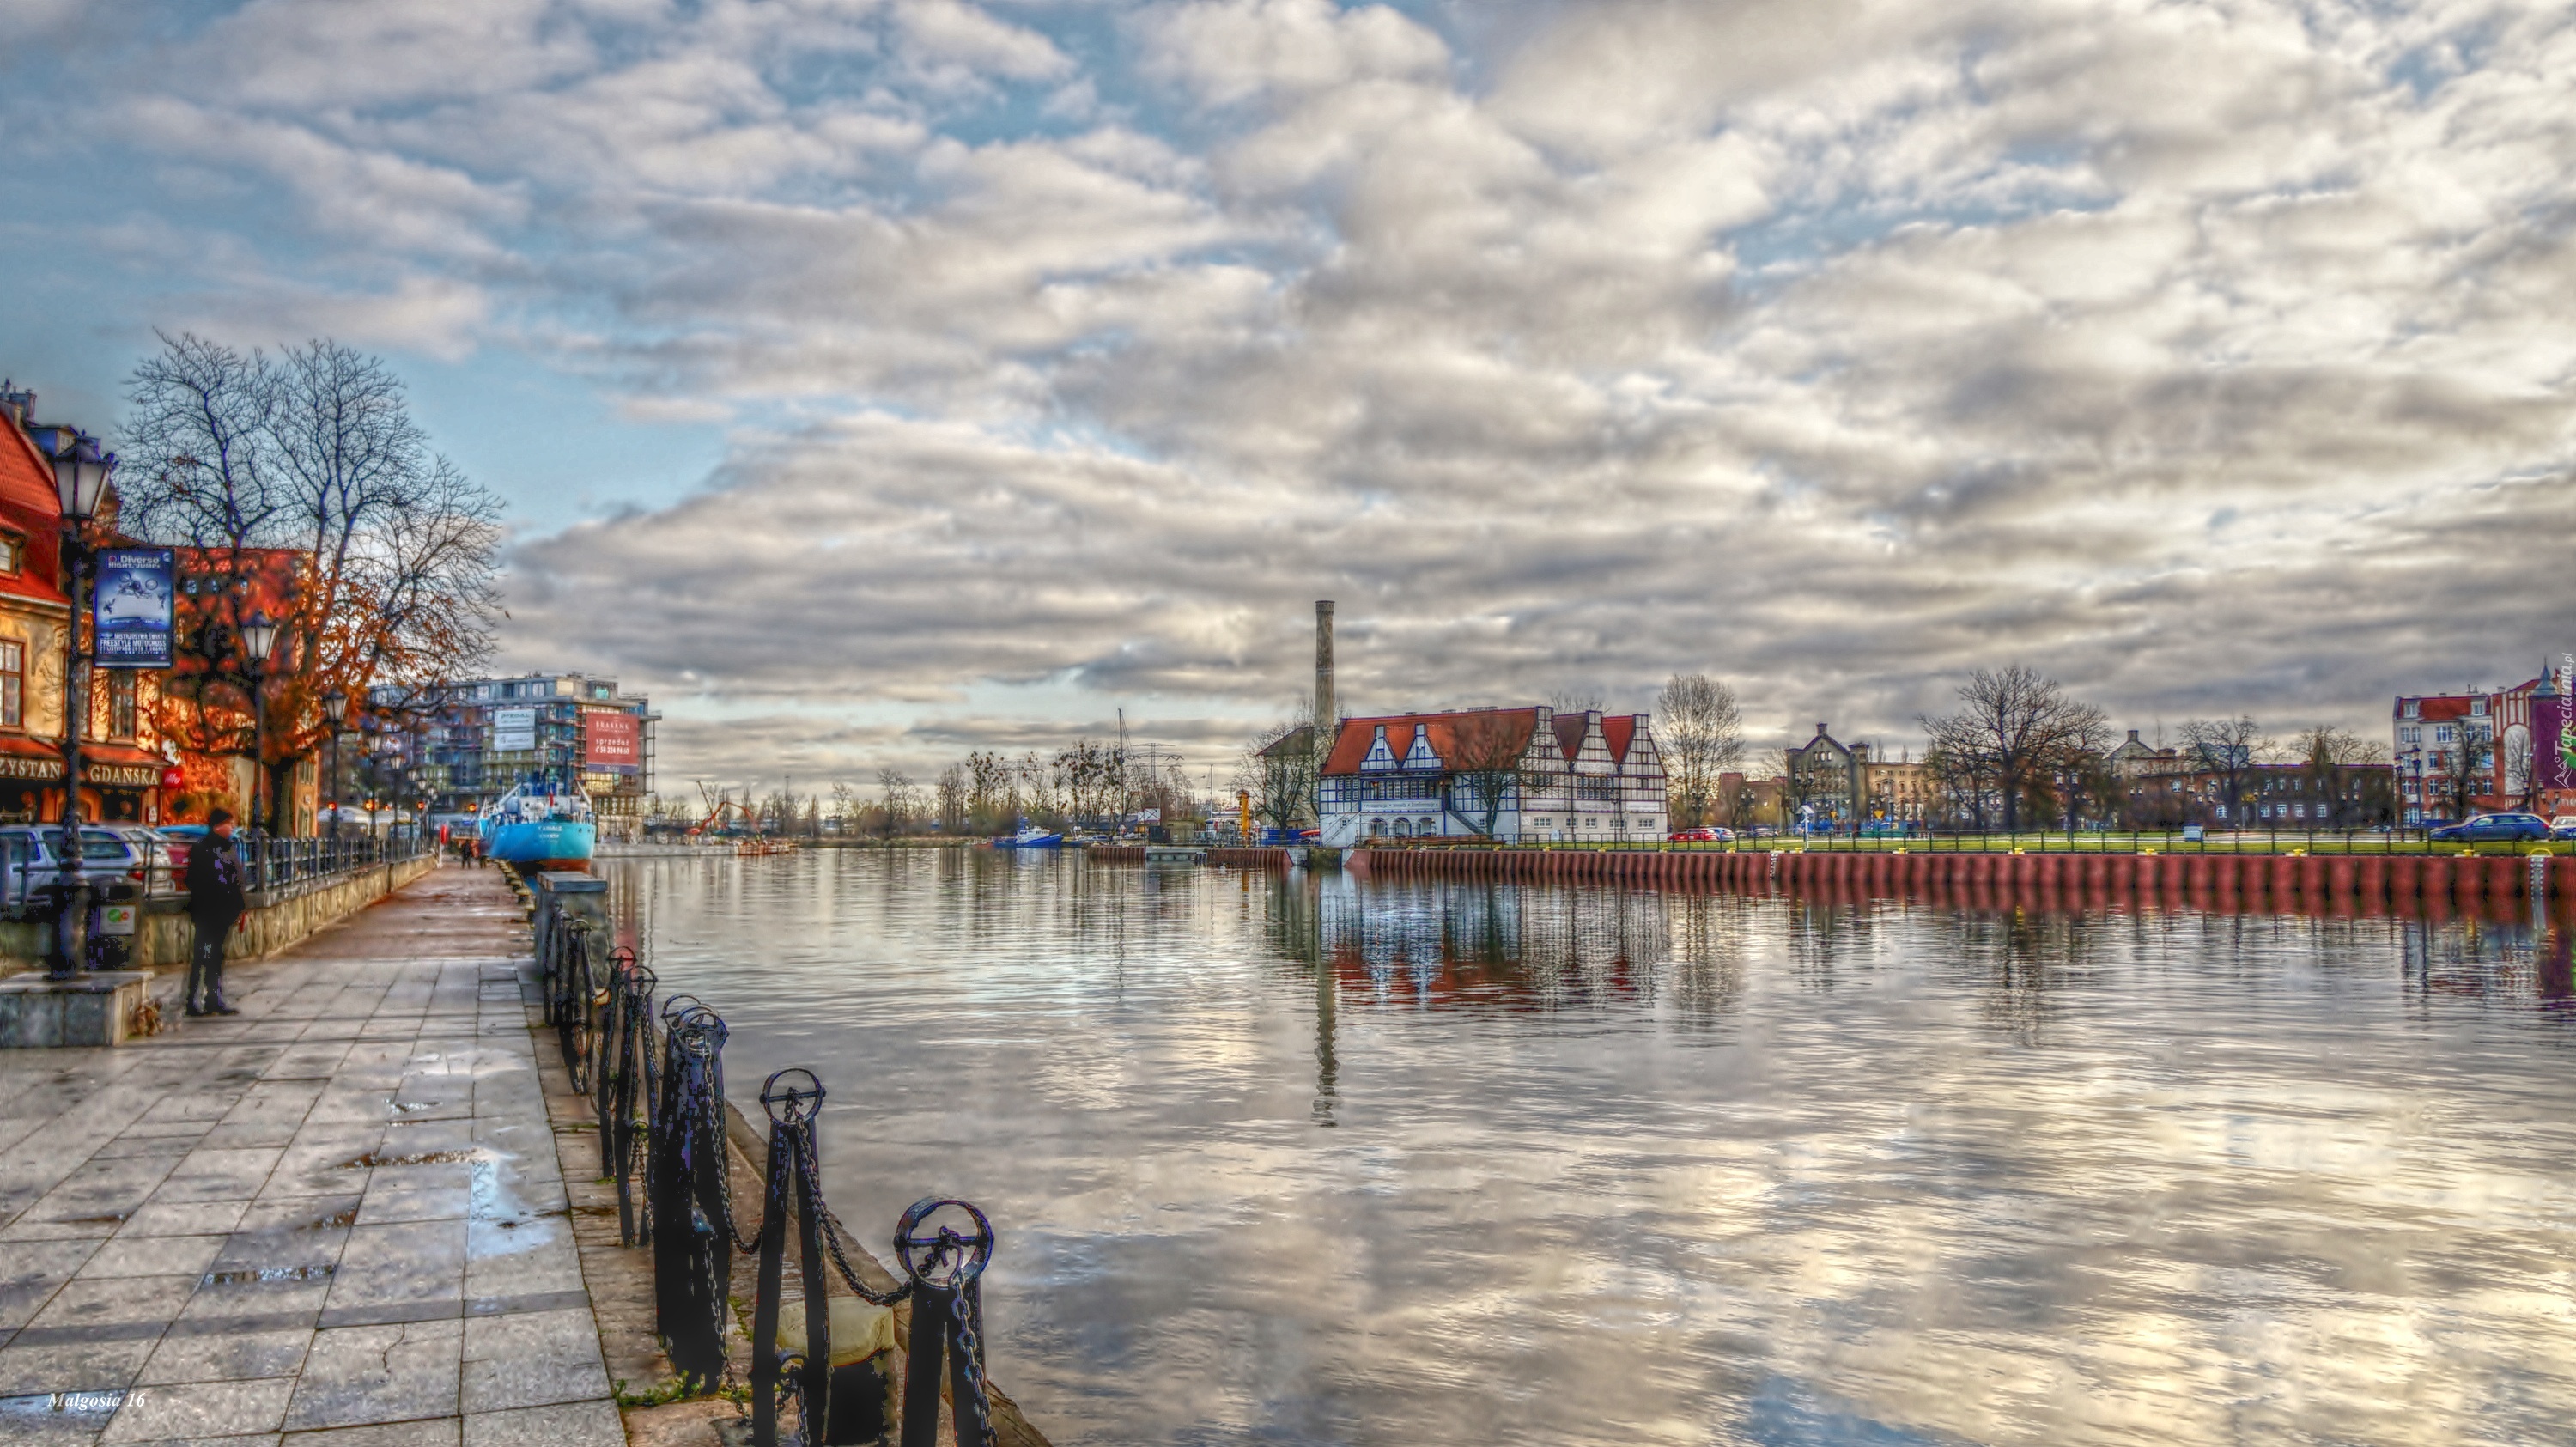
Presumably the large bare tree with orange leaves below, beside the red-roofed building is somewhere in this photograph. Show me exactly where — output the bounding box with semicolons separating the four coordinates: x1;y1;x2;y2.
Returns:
118;335;502;824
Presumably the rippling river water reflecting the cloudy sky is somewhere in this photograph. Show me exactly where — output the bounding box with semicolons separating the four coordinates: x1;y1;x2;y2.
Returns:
605;849;2576;1447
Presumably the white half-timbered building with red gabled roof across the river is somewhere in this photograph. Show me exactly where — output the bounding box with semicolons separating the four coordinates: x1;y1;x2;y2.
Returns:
1316;708;1669;849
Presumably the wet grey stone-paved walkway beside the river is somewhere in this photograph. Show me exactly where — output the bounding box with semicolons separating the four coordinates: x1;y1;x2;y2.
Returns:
0;867;626;1447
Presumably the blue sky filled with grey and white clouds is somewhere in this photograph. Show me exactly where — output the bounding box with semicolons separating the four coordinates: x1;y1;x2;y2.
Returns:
0;0;2576;787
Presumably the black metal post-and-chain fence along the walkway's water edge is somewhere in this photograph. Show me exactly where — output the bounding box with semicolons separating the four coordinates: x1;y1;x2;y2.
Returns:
538;916;997;1447
